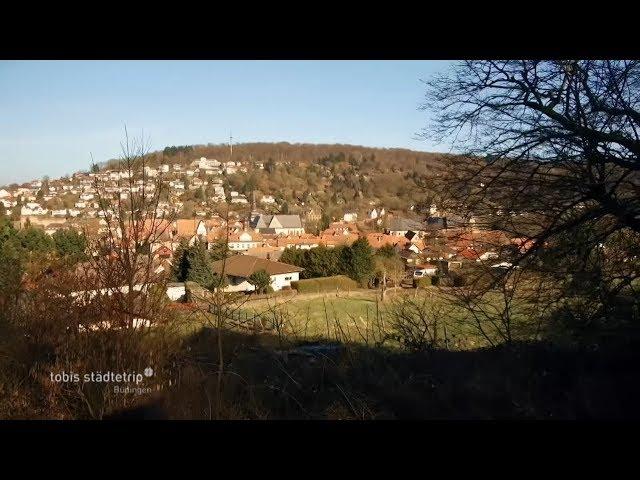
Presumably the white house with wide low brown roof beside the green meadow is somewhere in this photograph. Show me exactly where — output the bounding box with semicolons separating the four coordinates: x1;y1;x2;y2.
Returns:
212;255;304;292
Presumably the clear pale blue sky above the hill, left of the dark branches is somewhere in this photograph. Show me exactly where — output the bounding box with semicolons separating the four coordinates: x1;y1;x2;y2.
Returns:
0;60;450;185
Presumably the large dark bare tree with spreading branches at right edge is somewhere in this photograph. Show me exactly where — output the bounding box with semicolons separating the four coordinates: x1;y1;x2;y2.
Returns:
418;60;640;330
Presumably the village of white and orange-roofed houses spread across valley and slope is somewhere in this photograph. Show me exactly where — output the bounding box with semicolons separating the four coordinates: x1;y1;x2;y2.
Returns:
0;157;527;298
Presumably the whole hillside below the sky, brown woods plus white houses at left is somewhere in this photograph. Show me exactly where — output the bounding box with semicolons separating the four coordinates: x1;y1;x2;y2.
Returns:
0;142;450;231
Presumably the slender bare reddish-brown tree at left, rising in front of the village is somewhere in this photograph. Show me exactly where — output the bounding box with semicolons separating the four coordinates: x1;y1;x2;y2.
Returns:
89;129;174;328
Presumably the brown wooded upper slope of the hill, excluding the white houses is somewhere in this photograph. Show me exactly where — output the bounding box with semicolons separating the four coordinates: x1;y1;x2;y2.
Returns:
103;142;447;223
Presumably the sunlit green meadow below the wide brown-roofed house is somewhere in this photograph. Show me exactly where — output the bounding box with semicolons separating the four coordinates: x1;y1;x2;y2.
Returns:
224;288;485;349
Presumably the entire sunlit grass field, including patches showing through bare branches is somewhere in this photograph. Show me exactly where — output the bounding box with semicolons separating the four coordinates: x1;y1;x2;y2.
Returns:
169;287;540;350
